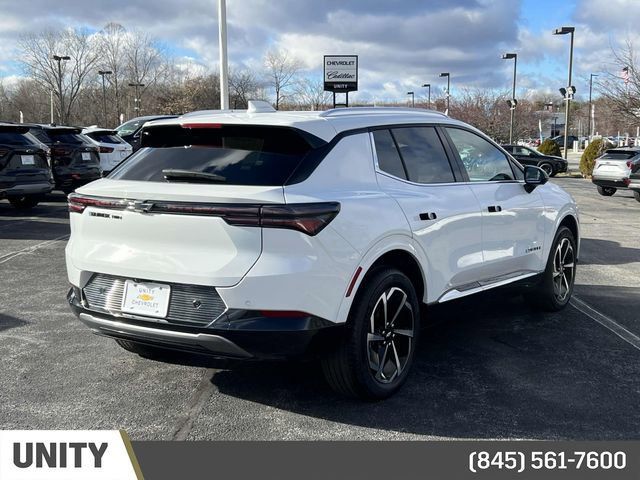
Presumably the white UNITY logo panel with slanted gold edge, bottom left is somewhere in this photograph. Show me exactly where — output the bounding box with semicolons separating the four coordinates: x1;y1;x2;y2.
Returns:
0;430;143;480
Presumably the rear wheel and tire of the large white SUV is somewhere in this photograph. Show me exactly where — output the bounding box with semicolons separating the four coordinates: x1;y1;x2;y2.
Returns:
322;267;420;401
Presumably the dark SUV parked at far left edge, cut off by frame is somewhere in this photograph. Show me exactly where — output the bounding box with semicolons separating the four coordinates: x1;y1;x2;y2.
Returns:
0;123;53;208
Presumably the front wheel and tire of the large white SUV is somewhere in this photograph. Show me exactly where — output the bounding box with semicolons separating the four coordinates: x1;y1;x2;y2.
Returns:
526;227;577;312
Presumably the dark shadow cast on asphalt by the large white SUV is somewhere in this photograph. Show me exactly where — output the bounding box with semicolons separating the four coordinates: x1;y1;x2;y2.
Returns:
178;292;640;440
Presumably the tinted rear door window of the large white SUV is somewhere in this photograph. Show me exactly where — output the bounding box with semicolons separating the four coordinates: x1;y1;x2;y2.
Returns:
392;127;455;183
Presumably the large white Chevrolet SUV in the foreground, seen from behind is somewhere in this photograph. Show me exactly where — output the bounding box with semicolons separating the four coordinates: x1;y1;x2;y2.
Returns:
66;102;579;399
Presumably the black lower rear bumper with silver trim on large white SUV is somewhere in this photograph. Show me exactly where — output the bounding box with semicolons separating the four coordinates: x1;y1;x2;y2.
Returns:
67;288;345;360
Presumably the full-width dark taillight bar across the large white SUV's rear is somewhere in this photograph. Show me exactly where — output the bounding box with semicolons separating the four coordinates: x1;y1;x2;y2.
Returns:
69;193;340;236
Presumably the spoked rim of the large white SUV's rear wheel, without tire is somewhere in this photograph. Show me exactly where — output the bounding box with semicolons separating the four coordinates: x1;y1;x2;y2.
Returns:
367;287;415;384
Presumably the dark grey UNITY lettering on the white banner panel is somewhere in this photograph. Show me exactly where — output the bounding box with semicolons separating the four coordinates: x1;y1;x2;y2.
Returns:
13;442;109;468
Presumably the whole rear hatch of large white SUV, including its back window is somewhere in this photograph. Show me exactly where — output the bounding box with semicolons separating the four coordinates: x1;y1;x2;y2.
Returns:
67;124;324;287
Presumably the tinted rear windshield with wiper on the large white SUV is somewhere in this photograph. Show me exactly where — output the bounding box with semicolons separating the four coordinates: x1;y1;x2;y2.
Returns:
110;125;321;186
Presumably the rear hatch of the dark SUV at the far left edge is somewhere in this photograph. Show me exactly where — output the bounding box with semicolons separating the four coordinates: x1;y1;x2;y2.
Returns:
0;125;51;188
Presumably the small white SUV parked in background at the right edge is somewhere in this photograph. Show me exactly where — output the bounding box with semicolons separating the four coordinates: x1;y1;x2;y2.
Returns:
591;147;640;197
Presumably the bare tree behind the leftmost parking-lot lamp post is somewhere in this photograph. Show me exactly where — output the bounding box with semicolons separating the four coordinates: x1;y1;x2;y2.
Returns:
19;29;98;124
